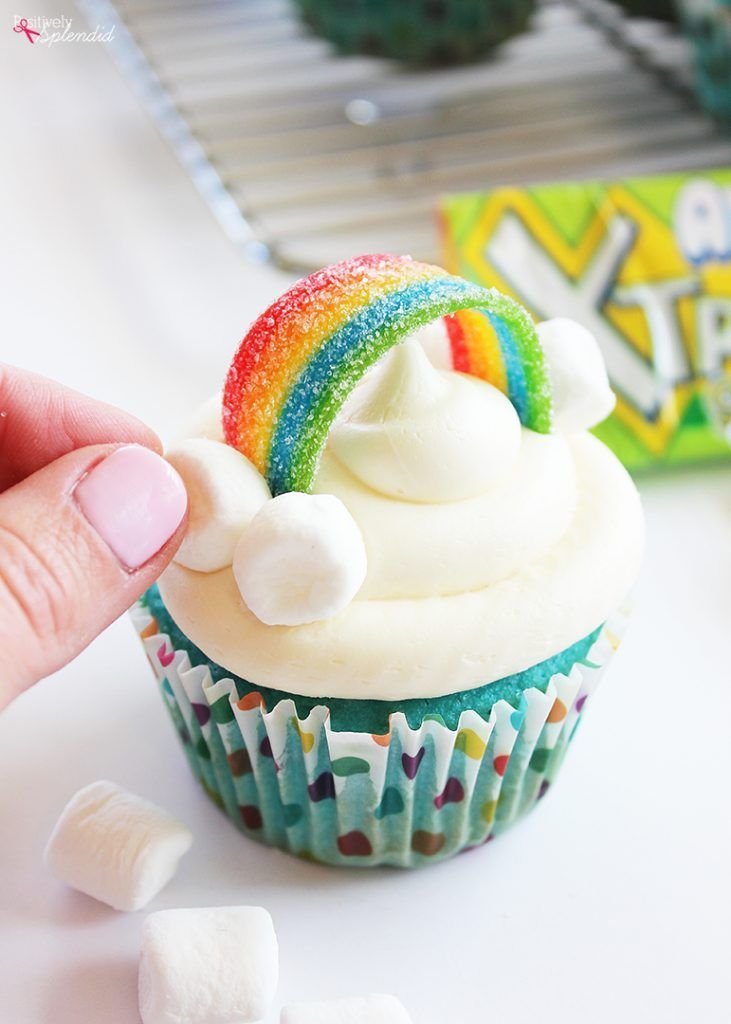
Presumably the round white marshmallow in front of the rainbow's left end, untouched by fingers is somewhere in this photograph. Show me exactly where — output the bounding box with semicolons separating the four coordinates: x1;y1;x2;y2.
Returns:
233;490;368;626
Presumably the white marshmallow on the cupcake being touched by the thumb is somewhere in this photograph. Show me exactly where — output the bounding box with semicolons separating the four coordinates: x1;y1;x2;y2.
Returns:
166;437;271;572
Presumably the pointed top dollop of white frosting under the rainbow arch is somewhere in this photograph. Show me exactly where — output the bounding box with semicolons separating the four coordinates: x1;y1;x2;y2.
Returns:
329;340;520;503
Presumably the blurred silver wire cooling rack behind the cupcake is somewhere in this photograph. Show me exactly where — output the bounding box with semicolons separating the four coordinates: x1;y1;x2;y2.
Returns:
79;0;731;270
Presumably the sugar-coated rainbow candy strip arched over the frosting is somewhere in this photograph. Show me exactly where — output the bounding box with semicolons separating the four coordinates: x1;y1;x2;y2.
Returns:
223;255;551;495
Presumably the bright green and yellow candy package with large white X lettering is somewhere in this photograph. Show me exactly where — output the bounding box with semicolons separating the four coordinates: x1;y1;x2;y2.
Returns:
440;168;731;470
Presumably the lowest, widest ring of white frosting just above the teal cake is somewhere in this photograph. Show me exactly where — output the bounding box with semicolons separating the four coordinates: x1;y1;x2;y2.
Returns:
161;434;643;700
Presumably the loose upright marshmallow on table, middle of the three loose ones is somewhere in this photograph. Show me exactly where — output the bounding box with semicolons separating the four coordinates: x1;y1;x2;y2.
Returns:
139;906;278;1024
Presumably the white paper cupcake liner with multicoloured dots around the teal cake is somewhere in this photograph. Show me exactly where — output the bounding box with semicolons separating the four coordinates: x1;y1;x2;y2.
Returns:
132;603;626;867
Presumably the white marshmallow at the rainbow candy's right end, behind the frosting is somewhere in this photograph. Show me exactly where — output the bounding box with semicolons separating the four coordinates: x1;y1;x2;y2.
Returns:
536;316;616;433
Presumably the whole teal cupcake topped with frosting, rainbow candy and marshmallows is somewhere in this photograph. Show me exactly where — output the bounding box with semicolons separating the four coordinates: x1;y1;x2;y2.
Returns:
133;256;643;866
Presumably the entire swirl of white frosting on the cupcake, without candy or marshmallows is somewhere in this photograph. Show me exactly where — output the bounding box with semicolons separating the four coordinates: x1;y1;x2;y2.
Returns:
161;331;643;700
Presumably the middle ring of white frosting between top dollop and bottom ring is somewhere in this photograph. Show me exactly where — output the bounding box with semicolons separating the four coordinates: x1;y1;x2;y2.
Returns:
314;430;576;598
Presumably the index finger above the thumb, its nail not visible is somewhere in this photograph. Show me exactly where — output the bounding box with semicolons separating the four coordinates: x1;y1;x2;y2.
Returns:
0;362;162;492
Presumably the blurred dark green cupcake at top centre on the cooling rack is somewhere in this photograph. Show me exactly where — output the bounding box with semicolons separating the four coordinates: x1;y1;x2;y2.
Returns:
295;0;535;66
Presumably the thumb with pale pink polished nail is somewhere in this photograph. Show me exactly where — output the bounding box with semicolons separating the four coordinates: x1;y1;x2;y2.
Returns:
0;444;187;707
